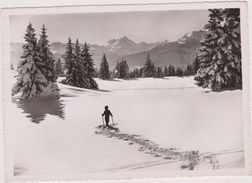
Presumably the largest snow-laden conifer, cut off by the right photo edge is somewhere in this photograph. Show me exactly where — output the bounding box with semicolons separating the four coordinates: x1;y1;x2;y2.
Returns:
195;9;242;90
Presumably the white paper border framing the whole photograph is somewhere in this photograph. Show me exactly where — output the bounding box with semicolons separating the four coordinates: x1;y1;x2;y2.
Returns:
1;1;251;181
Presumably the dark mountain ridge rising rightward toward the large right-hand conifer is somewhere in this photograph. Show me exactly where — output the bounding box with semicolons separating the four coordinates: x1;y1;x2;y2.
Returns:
125;31;205;69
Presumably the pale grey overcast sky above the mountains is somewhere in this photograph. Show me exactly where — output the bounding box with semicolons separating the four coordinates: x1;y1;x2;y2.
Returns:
10;10;208;44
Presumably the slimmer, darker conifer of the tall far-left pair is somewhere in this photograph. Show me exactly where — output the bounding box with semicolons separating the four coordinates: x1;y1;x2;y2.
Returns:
36;25;57;83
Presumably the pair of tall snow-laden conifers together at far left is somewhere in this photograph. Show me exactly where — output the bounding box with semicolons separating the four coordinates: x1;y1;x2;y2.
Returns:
12;23;59;100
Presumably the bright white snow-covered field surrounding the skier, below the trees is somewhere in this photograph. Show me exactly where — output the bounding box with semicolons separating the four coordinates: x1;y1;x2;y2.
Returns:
10;77;244;178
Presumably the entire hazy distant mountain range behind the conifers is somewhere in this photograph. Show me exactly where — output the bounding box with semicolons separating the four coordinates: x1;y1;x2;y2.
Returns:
11;31;204;68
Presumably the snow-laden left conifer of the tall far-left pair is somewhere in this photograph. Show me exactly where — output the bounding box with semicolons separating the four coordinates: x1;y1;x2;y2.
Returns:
12;23;47;100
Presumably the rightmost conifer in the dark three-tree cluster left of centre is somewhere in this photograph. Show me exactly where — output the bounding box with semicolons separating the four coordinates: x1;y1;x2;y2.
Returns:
81;42;98;89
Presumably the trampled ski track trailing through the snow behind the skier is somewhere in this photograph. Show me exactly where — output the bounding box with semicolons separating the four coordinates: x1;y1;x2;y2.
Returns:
95;125;224;170
